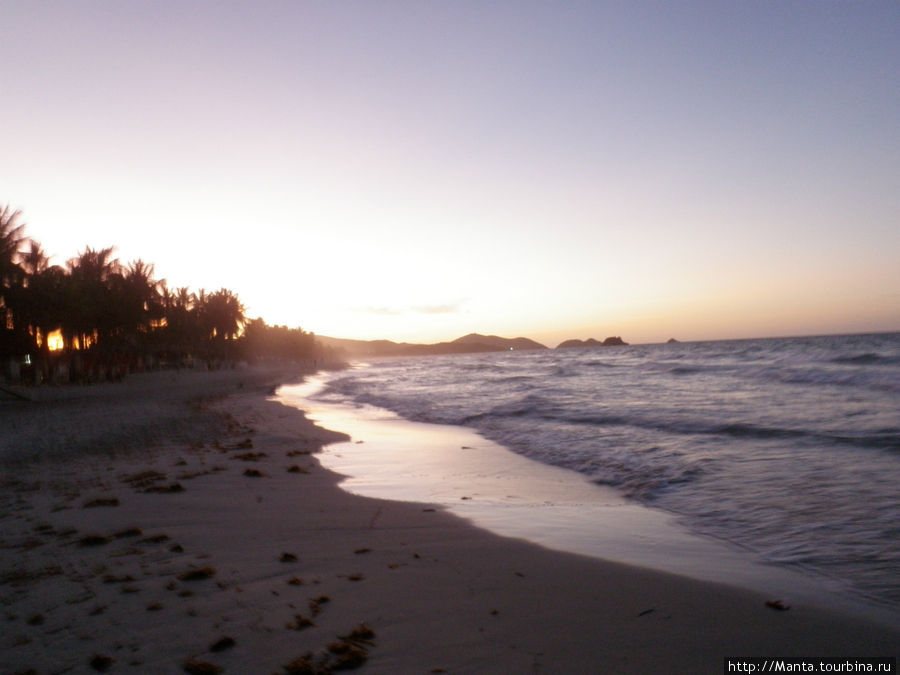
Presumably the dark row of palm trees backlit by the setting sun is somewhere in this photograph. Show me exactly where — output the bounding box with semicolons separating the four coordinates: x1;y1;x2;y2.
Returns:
0;205;318;382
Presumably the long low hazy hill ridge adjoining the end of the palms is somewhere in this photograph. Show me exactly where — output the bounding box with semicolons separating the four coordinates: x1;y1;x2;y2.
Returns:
316;333;547;357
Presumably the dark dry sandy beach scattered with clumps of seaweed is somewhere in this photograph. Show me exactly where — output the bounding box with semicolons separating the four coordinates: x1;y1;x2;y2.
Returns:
0;369;900;673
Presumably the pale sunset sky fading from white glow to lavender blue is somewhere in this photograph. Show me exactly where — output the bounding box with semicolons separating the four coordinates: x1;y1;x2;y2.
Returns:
0;0;900;346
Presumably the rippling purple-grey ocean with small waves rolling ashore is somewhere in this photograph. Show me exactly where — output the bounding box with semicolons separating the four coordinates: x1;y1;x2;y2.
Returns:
278;333;900;616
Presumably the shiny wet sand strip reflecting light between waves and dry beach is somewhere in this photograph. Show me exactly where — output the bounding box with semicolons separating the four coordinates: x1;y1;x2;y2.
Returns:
277;375;900;626
